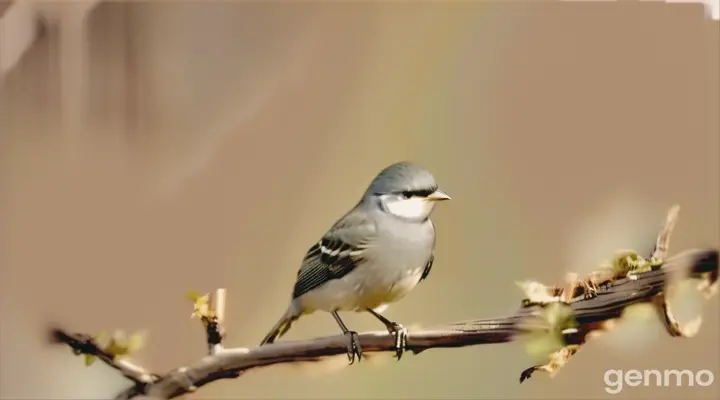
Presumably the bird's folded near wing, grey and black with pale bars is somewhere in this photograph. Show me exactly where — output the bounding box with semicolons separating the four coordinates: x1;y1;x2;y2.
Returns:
293;211;377;298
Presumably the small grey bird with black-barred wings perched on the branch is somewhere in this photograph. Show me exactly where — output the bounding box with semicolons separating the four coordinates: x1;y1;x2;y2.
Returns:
260;162;450;364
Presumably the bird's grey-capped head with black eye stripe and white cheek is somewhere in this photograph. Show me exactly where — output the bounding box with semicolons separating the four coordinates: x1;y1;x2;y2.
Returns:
364;161;450;221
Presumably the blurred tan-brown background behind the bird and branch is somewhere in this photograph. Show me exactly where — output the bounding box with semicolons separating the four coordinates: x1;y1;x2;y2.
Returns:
0;1;720;399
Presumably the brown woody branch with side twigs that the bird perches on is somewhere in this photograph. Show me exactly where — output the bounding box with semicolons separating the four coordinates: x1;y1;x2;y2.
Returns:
49;208;718;399
